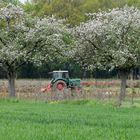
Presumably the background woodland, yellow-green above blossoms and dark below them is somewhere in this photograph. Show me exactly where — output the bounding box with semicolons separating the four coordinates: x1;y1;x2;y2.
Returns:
0;0;140;78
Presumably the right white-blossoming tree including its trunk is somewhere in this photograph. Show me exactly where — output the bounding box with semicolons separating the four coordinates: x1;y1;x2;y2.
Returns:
75;6;140;104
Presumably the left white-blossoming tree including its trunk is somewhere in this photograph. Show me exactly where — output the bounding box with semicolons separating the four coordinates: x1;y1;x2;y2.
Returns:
0;4;70;96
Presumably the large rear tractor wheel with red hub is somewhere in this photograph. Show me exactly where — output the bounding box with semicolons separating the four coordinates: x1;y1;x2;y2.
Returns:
53;80;67;92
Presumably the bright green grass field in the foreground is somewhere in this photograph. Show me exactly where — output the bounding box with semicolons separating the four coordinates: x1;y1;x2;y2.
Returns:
0;99;140;140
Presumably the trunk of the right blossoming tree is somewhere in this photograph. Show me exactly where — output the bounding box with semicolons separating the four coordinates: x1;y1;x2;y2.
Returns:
119;70;129;106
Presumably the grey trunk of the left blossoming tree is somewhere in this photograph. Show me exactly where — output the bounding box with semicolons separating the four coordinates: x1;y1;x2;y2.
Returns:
8;73;16;97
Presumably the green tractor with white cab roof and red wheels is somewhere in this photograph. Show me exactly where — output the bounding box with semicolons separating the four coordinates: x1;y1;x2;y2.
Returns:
42;70;80;92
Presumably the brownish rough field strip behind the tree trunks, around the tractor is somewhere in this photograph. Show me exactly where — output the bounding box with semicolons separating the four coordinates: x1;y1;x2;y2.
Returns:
0;79;140;102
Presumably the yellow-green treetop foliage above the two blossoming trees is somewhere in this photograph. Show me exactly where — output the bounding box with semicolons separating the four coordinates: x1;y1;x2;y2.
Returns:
24;0;140;26
